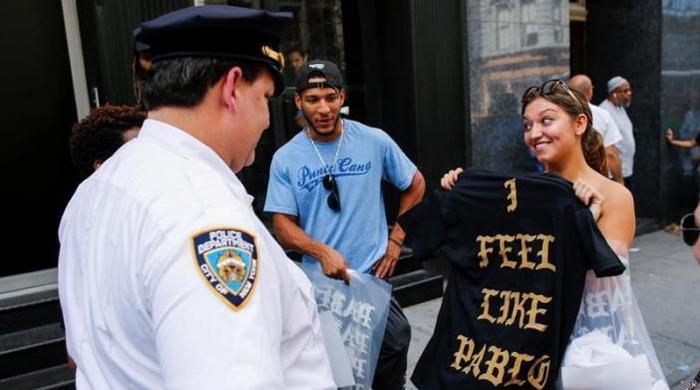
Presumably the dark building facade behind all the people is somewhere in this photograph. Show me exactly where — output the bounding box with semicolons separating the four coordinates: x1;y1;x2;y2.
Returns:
0;0;700;276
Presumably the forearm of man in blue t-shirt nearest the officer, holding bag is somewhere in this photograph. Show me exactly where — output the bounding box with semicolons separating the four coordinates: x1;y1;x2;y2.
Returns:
272;213;350;283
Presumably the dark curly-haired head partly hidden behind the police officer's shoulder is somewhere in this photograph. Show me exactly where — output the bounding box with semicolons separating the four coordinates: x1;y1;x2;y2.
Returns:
70;104;146;179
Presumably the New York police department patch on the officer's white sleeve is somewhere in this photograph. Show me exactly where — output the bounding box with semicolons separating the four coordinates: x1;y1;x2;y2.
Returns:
192;228;260;311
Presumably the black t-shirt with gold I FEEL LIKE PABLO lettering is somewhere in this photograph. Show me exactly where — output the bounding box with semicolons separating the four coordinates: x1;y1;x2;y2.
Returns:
399;170;624;389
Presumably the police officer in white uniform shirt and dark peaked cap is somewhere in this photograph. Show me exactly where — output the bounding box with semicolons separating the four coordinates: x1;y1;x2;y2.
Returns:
59;6;335;389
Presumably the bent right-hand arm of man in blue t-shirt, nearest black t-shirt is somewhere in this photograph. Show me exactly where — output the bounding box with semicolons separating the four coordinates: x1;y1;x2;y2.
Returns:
374;171;425;278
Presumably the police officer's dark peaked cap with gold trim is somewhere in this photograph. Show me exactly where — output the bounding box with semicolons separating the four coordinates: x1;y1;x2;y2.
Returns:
133;5;292;95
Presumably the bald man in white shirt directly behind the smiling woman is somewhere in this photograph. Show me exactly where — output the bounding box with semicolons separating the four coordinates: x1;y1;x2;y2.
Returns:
567;74;623;183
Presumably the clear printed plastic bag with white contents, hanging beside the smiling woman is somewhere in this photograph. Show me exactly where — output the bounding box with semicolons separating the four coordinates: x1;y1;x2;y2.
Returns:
559;244;669;390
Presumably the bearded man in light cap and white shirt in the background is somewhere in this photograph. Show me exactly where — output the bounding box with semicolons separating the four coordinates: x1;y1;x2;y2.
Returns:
600;76;635;193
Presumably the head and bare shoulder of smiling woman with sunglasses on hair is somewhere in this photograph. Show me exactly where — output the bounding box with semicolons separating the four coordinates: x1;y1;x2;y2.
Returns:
522;80;635;246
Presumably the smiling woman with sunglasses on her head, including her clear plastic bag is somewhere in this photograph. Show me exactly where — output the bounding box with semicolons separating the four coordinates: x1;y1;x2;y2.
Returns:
441;80;668;389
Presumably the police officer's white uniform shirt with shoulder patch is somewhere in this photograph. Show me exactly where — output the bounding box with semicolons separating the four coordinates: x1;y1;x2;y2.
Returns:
59;120;335;389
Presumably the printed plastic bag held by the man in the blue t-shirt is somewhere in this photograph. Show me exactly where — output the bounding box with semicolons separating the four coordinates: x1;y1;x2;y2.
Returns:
301;264;391;390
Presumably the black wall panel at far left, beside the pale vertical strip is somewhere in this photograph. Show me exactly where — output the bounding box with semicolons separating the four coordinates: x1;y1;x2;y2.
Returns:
0;0;77;276
